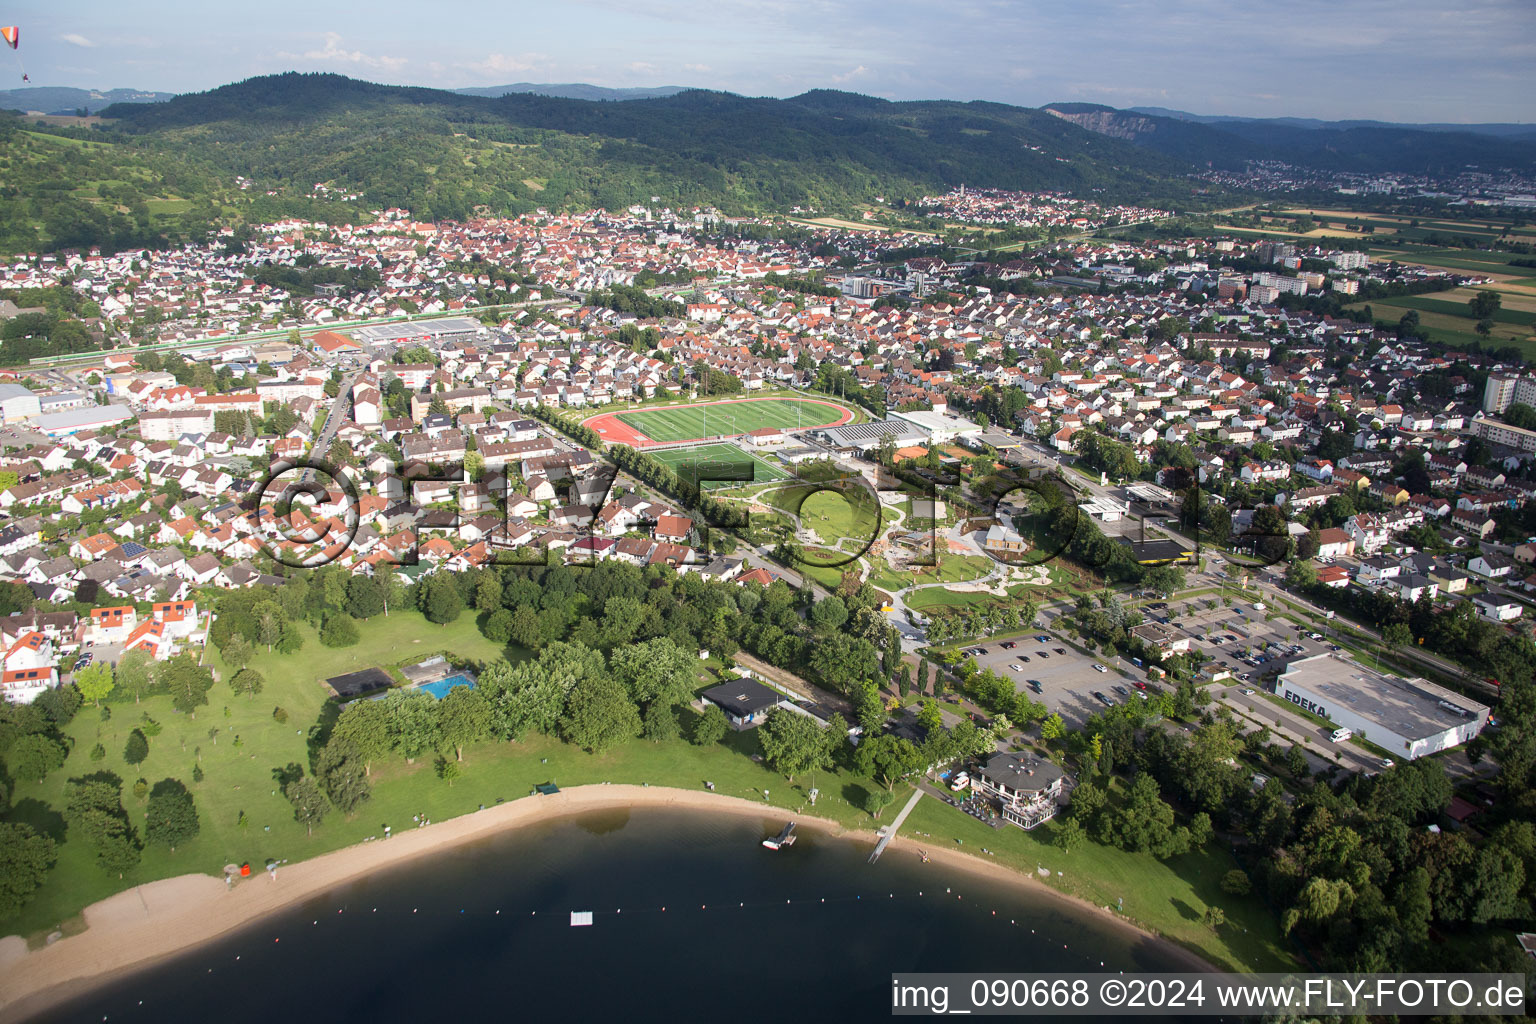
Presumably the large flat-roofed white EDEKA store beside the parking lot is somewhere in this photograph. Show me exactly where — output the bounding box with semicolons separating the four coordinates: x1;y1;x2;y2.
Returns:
1275;654;1488;760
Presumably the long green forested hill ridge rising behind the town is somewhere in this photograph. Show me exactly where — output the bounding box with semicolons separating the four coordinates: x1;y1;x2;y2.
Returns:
81;74;1192;216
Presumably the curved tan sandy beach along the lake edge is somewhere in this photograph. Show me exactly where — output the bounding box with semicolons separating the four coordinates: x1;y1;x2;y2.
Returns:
0;785;1213;1024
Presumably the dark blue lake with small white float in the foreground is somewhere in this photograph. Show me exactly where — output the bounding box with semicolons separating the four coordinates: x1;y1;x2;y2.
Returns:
35;808;1177;1024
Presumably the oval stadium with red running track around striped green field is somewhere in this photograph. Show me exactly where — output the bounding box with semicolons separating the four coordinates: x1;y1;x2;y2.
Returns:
585;398;854;447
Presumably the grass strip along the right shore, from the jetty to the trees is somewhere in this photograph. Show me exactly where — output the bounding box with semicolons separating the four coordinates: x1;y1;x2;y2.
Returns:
903;800;1296;970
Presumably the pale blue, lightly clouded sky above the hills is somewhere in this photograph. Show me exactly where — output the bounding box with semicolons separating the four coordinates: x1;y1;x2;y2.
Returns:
9;0;1536;121
